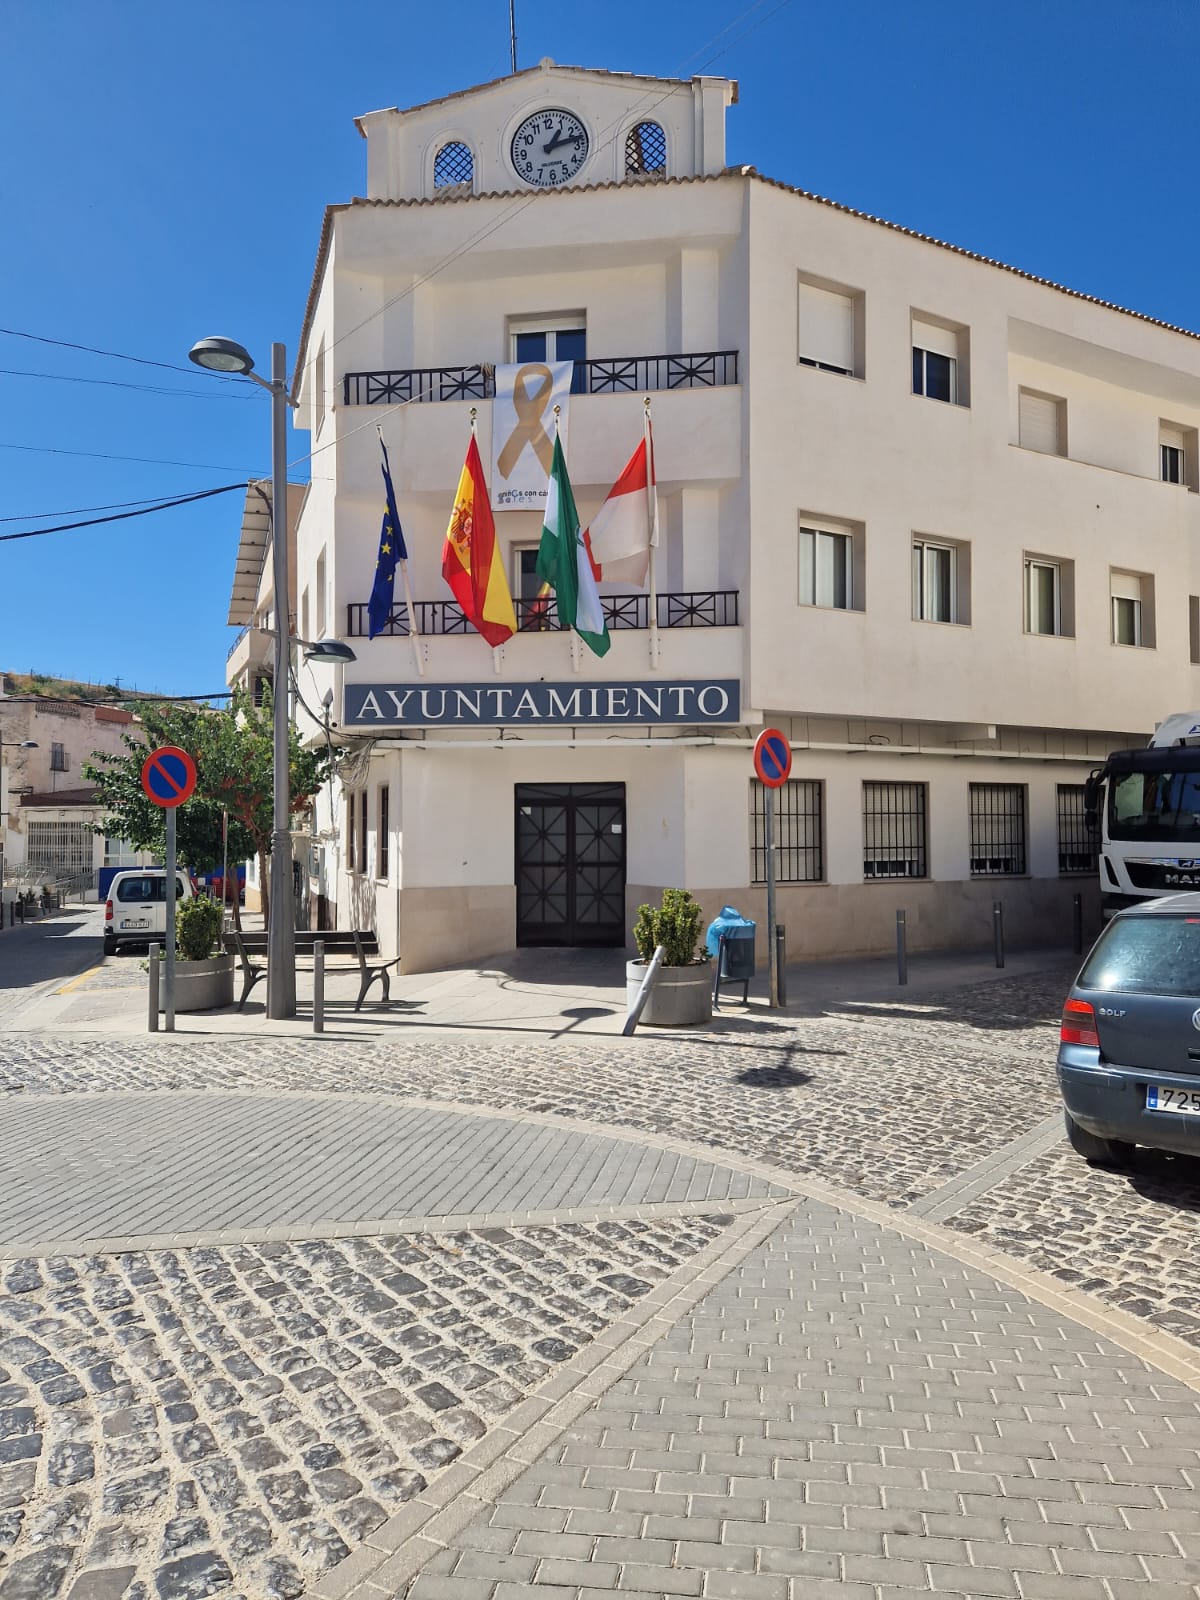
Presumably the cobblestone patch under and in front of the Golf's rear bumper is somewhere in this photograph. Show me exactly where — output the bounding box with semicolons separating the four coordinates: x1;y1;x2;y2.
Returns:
950;1149;1200;1346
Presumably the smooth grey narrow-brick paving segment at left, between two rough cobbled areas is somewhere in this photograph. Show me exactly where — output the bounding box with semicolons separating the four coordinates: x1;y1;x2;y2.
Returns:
0;1090;784;1256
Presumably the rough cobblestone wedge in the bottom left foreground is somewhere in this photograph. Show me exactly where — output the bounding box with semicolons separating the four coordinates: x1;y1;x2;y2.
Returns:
0;1213;730;1600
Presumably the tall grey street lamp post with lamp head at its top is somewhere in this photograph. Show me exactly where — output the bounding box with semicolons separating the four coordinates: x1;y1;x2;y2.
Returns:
187;338;296;1018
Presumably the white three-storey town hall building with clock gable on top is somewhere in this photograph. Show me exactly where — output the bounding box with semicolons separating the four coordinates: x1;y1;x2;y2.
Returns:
230;64;1200;970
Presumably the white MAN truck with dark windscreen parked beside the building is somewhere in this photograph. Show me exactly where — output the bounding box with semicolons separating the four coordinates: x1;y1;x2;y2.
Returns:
1083;710;1200;918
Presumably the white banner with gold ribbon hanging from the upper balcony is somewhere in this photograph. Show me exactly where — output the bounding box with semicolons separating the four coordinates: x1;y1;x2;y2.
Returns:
491;362;574;510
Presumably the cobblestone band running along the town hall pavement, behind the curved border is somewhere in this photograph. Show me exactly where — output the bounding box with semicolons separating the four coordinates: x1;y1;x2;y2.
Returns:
0;966;1067;1205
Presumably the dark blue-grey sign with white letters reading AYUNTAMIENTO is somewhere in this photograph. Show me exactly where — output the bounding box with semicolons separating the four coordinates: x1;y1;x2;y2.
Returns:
342;678;741;728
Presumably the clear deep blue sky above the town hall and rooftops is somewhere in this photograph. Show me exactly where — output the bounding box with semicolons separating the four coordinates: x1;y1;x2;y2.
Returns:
0;0;1200;694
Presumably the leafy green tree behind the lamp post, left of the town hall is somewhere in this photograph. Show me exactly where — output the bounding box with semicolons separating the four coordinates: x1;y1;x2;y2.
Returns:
83;690;330;917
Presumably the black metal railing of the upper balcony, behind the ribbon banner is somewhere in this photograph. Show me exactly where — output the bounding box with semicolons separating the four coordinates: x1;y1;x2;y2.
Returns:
342;350;738;405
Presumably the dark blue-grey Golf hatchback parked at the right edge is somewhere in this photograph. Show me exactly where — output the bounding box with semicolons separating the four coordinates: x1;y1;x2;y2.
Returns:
1058;894;1200;1166
